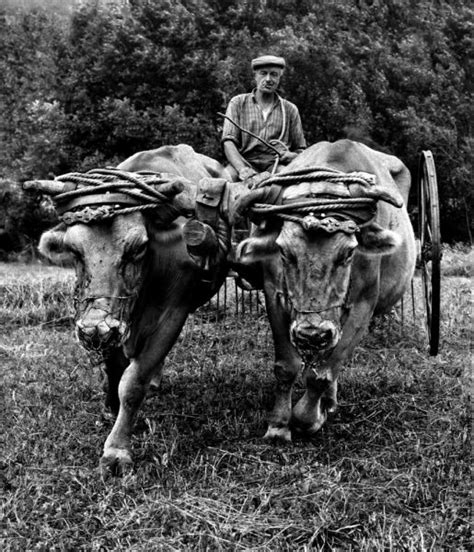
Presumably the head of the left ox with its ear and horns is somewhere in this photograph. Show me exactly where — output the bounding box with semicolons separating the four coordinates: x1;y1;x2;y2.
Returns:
25;170;187;357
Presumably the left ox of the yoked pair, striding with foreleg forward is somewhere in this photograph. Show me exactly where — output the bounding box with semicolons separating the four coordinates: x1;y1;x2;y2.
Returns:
34;145;230;473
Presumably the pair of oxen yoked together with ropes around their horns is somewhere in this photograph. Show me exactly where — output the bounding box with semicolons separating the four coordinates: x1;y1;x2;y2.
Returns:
29;140;415;473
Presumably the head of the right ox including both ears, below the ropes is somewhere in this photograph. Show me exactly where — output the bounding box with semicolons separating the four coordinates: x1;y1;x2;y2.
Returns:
236;175;401;361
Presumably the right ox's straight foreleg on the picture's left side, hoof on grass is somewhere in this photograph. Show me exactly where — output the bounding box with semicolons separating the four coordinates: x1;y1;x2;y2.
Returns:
264;293;301;442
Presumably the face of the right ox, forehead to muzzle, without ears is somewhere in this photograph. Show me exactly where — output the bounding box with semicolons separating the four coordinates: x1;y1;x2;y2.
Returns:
276;222;357;356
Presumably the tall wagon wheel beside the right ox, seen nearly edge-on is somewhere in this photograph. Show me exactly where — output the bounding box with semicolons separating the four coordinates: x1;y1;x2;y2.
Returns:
418;150;441;356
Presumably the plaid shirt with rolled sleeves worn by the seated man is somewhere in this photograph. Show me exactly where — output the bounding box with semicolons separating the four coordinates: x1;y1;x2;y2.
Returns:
222;90;306;170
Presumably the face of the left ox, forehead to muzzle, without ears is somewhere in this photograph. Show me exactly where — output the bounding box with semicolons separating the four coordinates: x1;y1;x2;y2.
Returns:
64;213;148;352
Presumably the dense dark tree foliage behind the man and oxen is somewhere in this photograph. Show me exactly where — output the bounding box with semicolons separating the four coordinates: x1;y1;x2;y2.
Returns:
0;0;474;241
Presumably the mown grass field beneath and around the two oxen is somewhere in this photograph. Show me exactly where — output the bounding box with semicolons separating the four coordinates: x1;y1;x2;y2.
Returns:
0;249;473;551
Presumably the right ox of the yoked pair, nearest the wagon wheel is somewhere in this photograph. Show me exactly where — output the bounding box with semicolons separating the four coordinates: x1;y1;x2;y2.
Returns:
235;140;415;441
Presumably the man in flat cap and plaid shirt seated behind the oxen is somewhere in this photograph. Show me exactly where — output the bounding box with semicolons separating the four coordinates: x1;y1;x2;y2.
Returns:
222;55;306;180
